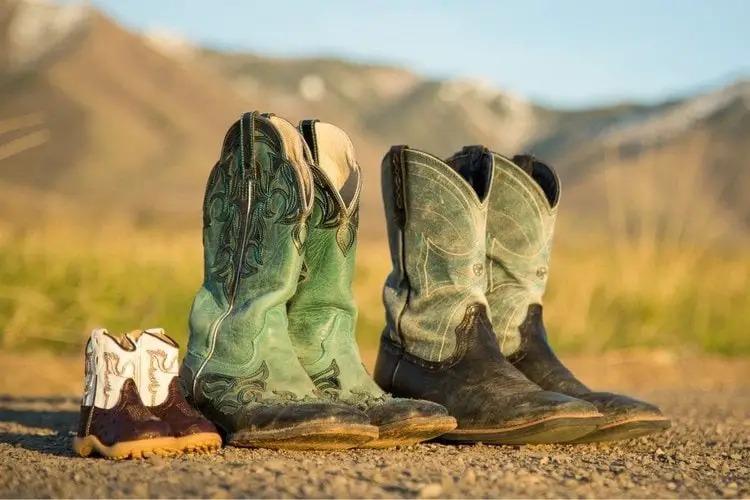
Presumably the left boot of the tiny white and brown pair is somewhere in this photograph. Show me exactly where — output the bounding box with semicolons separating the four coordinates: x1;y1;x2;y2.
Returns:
73;328;178;459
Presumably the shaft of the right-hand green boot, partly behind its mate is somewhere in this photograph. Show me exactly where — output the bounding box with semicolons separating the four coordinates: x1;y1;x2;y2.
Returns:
287;120;362;364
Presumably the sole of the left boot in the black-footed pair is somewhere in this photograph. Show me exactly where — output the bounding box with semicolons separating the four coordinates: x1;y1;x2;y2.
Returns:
440;415;602;444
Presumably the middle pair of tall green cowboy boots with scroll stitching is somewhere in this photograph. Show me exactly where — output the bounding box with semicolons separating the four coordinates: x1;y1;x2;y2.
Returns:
180;112;456;449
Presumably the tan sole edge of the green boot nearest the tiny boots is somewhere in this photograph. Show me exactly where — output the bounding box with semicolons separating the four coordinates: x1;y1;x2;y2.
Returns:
227;423;378;450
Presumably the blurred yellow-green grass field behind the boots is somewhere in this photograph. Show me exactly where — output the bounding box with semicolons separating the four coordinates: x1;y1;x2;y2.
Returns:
0;217;750;355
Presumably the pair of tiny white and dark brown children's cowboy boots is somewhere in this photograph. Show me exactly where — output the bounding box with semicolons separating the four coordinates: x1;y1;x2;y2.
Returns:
73;328;221;459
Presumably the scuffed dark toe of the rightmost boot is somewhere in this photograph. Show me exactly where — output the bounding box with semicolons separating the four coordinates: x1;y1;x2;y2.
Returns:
575;392;672;443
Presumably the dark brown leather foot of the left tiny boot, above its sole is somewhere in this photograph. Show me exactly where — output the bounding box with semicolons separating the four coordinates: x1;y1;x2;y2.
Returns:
78;378;172;446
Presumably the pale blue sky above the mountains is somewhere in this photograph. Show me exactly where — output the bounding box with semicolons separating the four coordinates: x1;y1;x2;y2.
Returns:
60;0;750;107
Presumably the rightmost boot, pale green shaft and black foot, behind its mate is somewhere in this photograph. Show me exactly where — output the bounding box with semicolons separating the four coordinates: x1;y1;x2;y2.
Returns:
462;146;670;442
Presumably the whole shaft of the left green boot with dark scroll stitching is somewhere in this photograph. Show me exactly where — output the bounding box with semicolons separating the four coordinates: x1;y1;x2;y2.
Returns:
187;112;313;377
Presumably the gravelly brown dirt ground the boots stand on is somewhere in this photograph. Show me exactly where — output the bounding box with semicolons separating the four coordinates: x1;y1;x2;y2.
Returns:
0;353;750;498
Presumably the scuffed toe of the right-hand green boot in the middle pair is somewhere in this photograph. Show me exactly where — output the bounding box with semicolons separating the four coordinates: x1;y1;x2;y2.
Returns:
363;398;457;448
